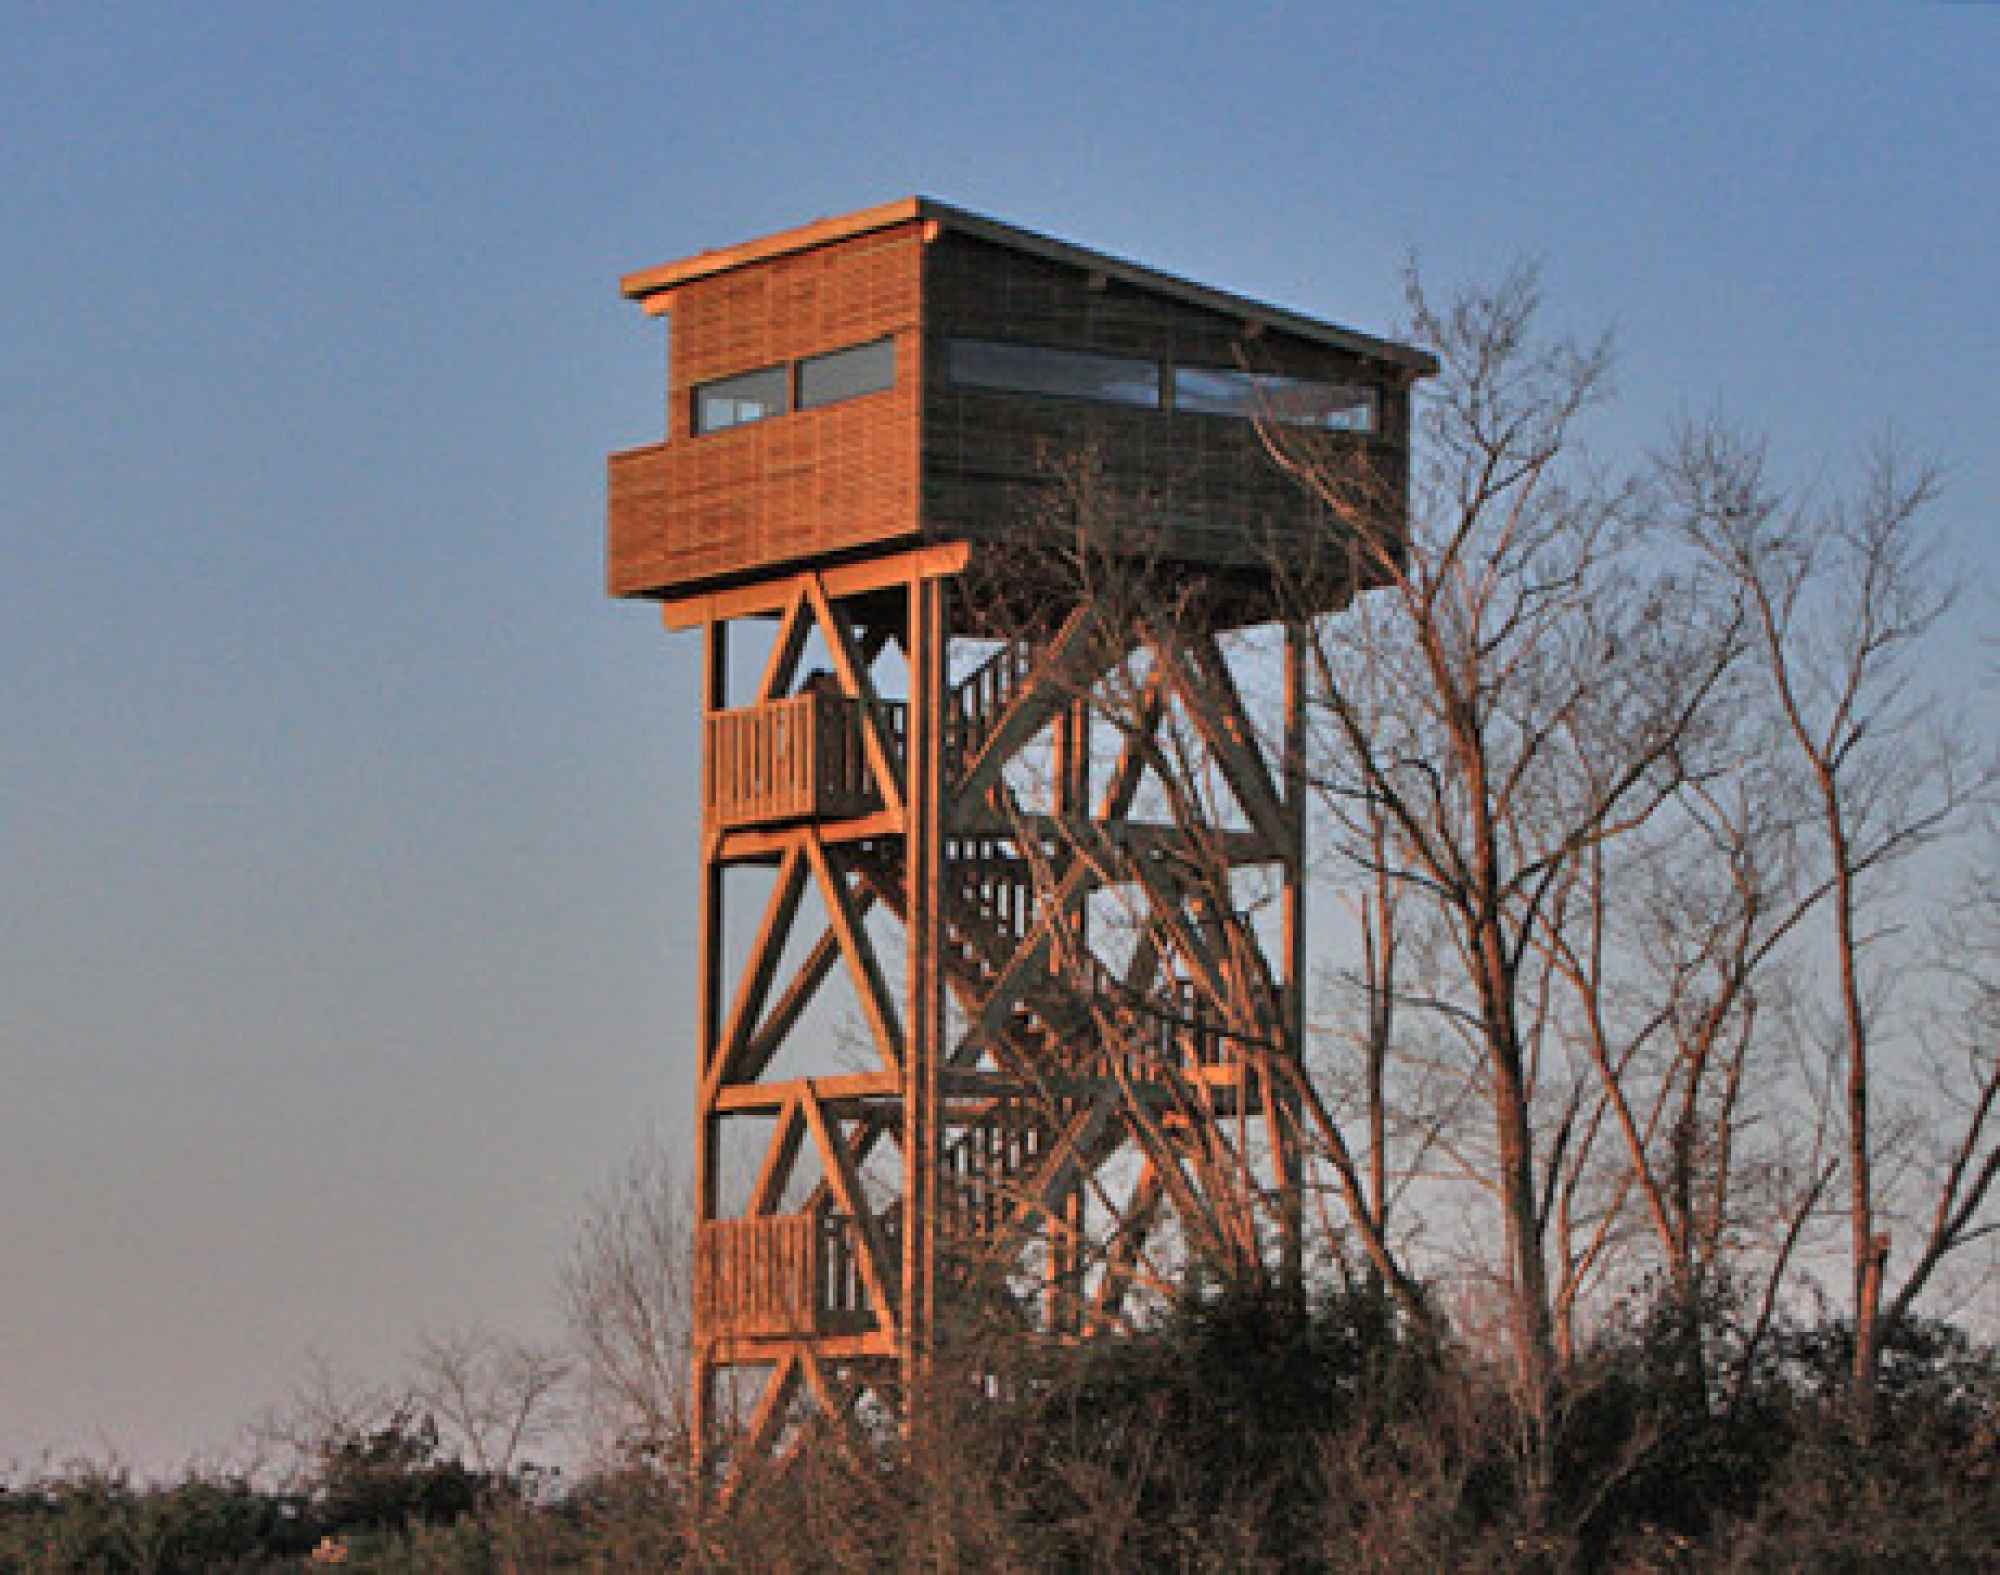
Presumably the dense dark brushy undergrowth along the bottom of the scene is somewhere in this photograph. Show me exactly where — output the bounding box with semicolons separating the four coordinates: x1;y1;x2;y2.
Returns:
0;1287;2000;1571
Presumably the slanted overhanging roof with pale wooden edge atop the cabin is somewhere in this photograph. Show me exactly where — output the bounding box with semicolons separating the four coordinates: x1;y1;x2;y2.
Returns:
620;196;1438;374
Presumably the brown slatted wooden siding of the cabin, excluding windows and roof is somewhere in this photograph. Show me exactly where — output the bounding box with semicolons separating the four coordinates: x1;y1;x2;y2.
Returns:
606;210;1416;606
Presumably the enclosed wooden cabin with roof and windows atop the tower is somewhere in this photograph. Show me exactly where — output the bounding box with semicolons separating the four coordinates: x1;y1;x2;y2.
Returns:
608;198;1436;622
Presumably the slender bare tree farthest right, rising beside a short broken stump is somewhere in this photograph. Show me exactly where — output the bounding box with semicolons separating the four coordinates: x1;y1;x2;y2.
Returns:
1664;426;1994;1399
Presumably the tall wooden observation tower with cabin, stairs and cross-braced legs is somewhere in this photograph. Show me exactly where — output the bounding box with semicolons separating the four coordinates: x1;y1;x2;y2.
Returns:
608;200;1434;1453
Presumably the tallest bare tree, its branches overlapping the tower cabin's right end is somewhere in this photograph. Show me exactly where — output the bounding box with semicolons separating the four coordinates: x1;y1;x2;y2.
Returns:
1272;272;1734;1407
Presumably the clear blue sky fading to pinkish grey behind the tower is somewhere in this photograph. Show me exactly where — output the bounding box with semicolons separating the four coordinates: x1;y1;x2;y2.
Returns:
0;0;2000;1467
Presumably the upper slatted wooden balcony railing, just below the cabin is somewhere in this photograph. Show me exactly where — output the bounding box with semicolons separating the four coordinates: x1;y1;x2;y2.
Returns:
702;694;906;829
